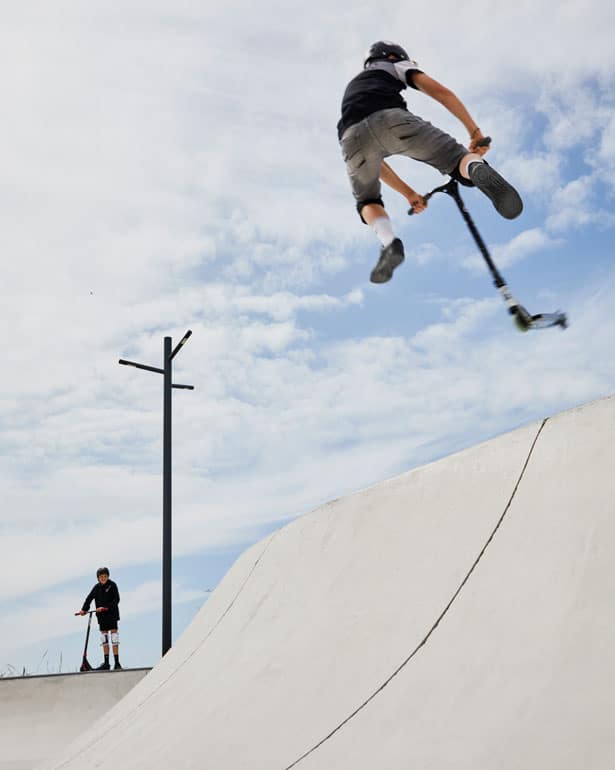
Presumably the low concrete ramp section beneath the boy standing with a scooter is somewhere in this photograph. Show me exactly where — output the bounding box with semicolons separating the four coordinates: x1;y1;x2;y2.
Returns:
0;668;149;770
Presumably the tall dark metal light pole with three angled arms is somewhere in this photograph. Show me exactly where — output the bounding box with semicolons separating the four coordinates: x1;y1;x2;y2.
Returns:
119;329;194;655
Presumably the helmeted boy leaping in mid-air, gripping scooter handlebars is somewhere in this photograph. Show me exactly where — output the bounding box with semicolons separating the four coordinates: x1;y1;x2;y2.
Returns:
337;40;523;283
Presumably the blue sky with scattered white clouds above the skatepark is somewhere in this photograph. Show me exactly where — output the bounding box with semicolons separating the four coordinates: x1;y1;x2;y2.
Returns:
0;0;615;672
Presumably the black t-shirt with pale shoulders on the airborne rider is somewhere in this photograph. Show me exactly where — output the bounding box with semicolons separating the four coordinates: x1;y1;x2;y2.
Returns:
337;61;421;139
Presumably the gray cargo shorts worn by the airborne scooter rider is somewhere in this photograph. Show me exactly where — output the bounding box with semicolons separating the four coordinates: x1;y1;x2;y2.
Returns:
340;108;468;219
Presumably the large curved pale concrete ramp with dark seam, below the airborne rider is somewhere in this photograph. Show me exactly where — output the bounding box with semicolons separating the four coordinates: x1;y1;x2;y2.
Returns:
37;398;615;770
